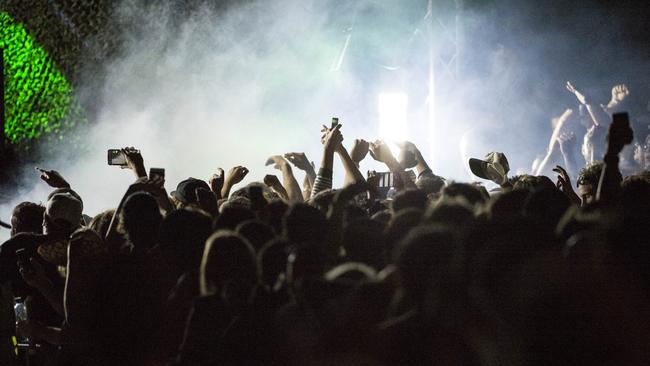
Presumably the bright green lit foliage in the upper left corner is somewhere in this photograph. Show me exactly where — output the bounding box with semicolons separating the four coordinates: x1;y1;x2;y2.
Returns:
0;12;85;145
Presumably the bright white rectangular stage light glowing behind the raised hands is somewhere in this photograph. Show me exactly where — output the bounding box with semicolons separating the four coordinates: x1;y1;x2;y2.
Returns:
378;93;408;148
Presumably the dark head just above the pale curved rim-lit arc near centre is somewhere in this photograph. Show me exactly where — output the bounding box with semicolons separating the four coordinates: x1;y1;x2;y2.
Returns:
343;219;386;270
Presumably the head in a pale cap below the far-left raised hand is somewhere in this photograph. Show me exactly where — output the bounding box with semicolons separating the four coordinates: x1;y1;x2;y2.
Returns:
43;192;83;234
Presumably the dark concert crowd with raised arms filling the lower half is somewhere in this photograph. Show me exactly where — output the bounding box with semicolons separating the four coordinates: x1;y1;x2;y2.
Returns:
0;83;650;366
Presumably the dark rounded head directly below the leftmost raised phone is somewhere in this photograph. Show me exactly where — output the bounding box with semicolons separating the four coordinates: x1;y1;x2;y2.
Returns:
119;192;162;250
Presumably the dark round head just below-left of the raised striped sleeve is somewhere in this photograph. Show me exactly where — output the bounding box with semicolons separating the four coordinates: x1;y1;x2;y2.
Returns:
283;203;329;245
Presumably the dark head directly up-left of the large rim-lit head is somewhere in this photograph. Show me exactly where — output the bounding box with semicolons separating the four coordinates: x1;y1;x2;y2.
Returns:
159;209;212;271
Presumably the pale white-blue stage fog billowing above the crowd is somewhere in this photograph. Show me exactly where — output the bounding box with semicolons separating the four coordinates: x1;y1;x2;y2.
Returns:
0;0;644;239
